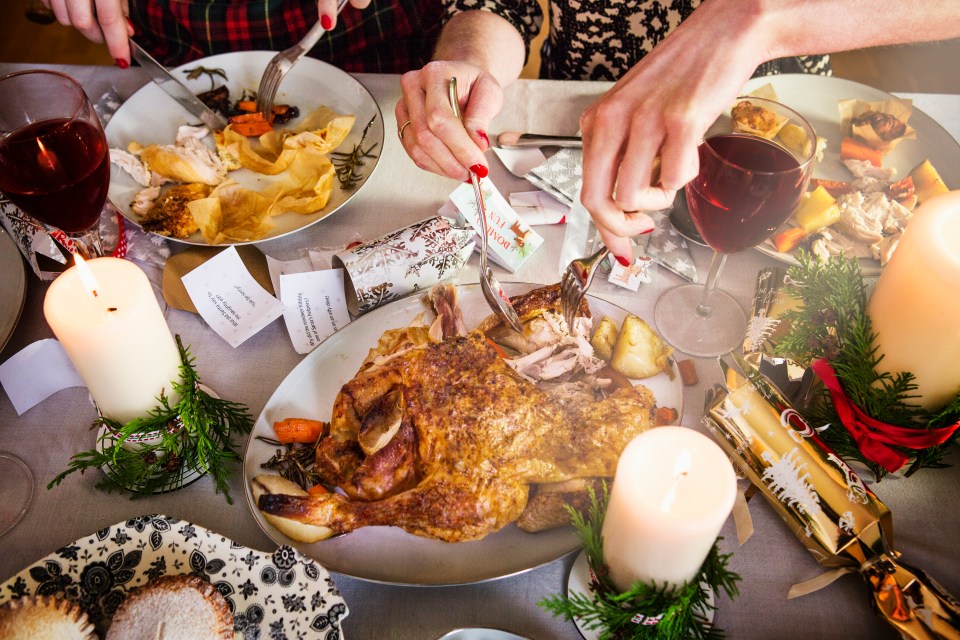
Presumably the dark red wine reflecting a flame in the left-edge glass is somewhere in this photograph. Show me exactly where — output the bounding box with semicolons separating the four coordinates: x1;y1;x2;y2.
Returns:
0;118;110;233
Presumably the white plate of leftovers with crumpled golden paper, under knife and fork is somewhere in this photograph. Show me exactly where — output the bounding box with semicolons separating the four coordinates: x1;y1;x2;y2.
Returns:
105;51;383;245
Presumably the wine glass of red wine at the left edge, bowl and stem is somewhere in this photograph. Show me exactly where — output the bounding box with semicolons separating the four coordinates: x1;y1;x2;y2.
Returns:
0;70;110;257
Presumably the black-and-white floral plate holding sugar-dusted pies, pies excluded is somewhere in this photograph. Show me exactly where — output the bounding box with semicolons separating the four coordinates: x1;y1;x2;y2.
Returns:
0;515;348;640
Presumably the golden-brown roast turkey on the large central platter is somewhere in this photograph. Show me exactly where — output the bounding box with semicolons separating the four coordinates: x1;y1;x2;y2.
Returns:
258;287;656;542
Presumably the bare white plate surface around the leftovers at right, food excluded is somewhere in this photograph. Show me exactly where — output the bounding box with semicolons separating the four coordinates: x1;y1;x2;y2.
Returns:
743;74;960;274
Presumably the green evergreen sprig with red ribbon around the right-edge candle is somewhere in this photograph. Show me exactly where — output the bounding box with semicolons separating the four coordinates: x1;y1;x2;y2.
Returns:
774;251;960;480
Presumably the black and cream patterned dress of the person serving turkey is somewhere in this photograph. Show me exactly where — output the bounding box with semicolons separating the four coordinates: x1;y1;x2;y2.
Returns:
446;0;831;80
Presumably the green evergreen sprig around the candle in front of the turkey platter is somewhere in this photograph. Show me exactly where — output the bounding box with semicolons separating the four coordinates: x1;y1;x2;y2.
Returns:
537;485;740;640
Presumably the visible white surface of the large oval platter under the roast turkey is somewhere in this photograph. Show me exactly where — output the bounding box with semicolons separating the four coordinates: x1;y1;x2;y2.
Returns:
243;283;683;585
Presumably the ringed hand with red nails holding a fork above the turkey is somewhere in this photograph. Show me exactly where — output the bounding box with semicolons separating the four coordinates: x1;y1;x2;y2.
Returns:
395;61;503;181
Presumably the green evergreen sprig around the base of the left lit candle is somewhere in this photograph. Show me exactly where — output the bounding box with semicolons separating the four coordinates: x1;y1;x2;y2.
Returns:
47;336;253;504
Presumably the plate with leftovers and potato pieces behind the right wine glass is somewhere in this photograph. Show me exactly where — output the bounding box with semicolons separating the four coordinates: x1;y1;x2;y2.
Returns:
743;74;960;274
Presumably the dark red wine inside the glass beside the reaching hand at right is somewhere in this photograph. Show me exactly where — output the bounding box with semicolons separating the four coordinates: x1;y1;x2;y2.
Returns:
687;133;808;253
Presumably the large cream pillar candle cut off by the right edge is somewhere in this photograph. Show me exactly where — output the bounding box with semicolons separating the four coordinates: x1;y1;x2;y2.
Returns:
867;191;960;410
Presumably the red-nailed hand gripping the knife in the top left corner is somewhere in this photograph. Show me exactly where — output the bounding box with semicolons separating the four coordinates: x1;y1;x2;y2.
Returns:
43;0;133;69
